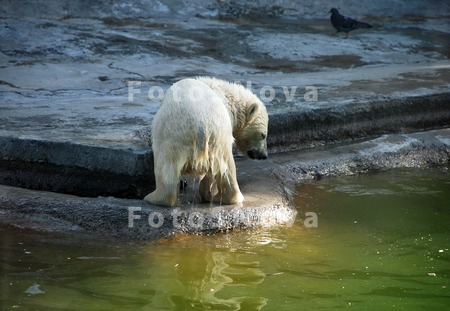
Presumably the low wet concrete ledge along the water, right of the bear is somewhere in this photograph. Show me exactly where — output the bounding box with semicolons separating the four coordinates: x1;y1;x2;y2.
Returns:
274;129;450;184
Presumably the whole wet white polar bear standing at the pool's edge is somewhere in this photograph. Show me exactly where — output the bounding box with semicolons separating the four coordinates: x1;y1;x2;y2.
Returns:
144;77;269;206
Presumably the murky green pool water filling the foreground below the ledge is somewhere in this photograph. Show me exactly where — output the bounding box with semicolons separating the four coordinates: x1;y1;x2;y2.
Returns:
0;168;450;311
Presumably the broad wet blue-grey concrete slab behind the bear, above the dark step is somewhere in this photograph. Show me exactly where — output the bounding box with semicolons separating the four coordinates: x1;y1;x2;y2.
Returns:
0;17;450;149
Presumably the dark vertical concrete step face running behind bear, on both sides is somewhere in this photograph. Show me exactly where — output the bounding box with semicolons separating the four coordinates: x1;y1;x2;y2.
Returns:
0;93;450;198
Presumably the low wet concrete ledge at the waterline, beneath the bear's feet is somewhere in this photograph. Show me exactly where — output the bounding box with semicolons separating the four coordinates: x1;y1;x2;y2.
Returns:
0;129;450;239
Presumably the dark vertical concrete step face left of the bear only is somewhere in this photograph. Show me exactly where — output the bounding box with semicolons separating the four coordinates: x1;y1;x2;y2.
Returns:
0;137;154;198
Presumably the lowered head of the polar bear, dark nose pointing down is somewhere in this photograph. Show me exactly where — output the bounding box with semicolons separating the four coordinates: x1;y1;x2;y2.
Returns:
233;100;269;160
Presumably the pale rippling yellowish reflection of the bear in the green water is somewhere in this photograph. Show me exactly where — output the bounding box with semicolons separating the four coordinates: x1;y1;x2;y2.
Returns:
142;235;268;310
